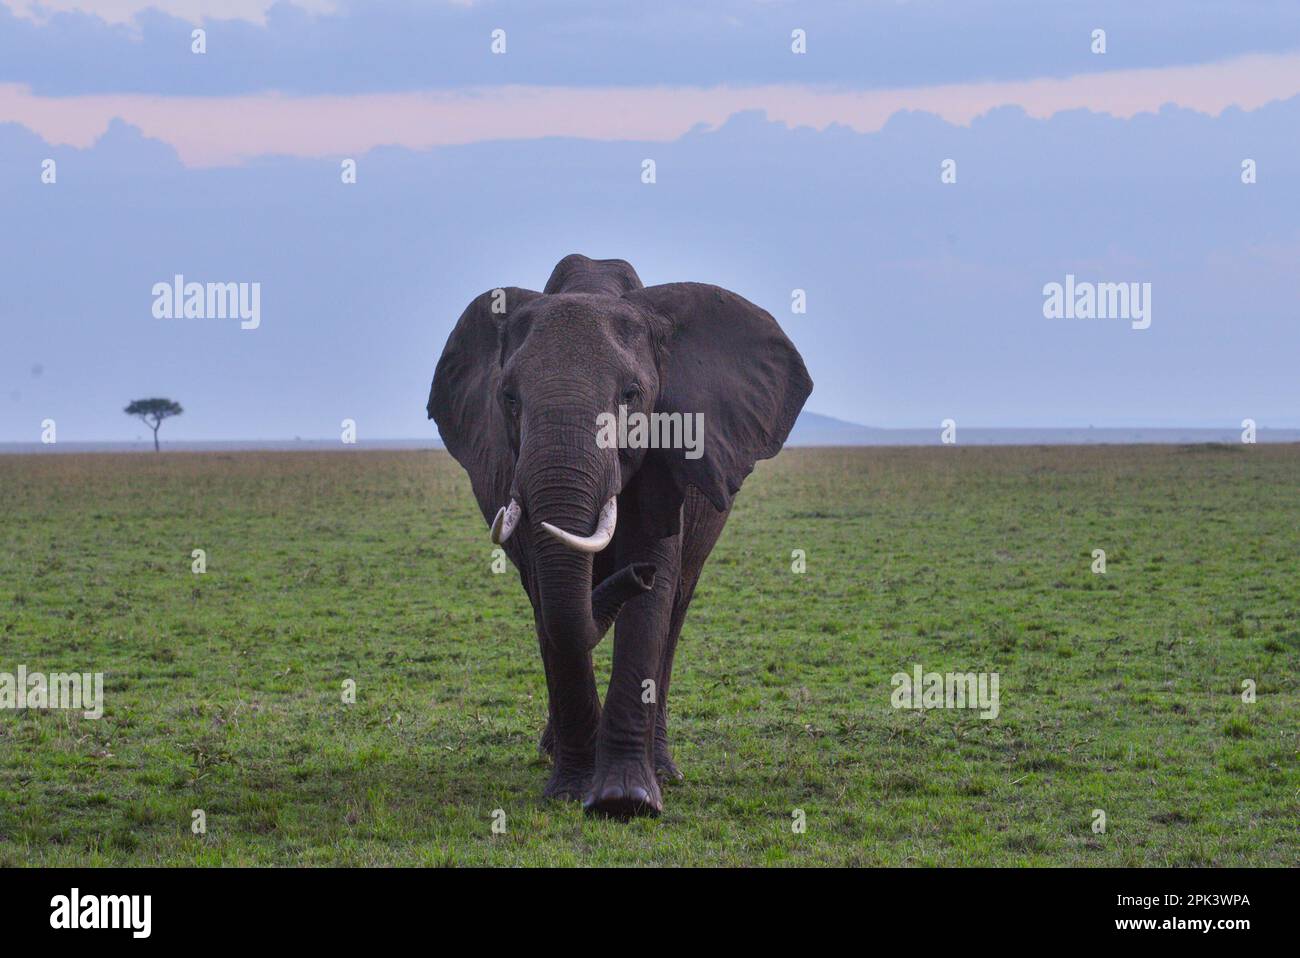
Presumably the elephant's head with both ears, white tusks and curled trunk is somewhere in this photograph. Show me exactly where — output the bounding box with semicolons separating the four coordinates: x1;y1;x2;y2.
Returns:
428;255;813;645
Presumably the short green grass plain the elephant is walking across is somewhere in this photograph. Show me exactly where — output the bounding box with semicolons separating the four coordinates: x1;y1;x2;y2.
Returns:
0;446;1300;866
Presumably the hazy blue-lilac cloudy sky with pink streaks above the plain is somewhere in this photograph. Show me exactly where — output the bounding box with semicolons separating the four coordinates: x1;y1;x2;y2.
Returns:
0;0;1300;442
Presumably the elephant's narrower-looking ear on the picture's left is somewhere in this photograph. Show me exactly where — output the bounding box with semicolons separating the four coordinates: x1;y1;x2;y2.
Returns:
428;286;542;521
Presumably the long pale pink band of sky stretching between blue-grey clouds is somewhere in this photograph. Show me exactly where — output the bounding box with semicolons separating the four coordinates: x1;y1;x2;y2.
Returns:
10;53;1300;166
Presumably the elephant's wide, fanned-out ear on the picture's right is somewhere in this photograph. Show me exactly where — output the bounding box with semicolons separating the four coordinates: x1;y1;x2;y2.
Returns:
624;283;813;512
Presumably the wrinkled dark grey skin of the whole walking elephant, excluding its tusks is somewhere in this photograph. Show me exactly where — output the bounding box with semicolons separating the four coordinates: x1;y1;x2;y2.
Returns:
428;255;813;818
